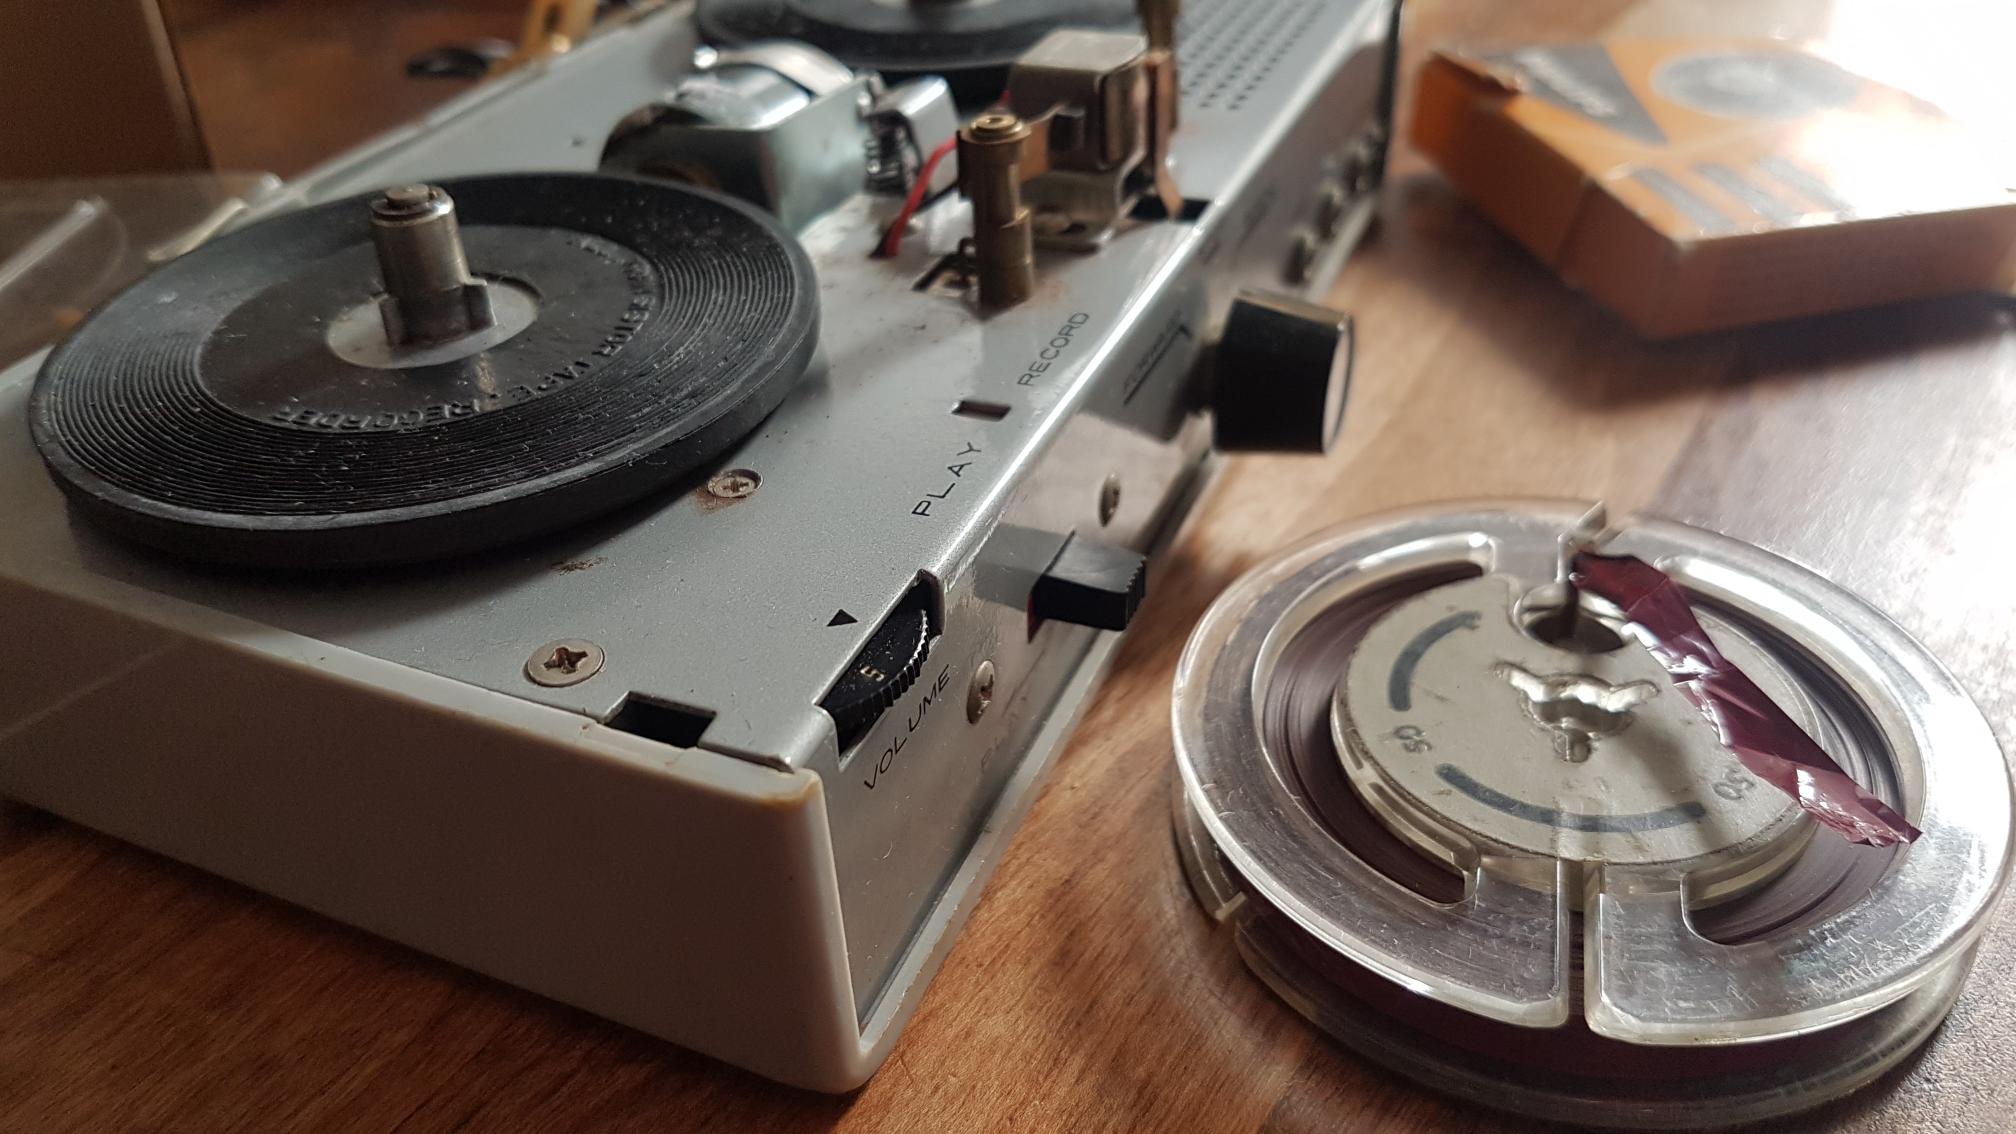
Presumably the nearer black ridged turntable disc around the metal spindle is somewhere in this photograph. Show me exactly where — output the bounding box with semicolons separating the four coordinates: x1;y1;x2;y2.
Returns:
28;174;818;567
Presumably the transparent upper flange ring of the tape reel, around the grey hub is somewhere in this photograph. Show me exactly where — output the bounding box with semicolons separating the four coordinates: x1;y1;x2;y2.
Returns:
1173;502;2010;1045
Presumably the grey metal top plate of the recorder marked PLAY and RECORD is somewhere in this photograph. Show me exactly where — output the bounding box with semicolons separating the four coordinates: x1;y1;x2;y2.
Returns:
0;0;1375;765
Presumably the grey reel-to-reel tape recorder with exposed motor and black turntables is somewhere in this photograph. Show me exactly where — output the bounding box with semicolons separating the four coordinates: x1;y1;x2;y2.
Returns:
0;0;1397;1090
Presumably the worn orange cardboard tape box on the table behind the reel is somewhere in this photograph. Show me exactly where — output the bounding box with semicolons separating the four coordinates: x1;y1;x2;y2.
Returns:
1413;40;2016;339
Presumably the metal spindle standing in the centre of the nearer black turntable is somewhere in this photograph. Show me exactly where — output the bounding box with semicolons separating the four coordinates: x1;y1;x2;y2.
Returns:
371;186;496;347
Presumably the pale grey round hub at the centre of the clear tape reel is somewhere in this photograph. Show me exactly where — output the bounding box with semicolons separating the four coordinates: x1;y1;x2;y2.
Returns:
1331;575;1816;900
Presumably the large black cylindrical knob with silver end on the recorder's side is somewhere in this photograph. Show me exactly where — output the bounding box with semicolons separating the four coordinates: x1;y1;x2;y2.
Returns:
1212;293;1353;454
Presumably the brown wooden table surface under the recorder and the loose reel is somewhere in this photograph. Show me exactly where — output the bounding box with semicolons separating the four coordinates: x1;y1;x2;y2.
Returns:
0;0;2016;1134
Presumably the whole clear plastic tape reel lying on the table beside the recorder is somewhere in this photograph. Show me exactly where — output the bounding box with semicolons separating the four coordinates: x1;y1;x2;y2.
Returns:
1173;502;2010;1128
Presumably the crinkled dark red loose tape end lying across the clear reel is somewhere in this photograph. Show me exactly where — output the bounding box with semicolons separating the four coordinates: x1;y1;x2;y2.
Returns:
1572;551;1919;847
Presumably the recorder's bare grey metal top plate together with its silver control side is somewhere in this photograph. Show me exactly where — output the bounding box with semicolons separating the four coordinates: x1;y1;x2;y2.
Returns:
0;0;1389;1017
